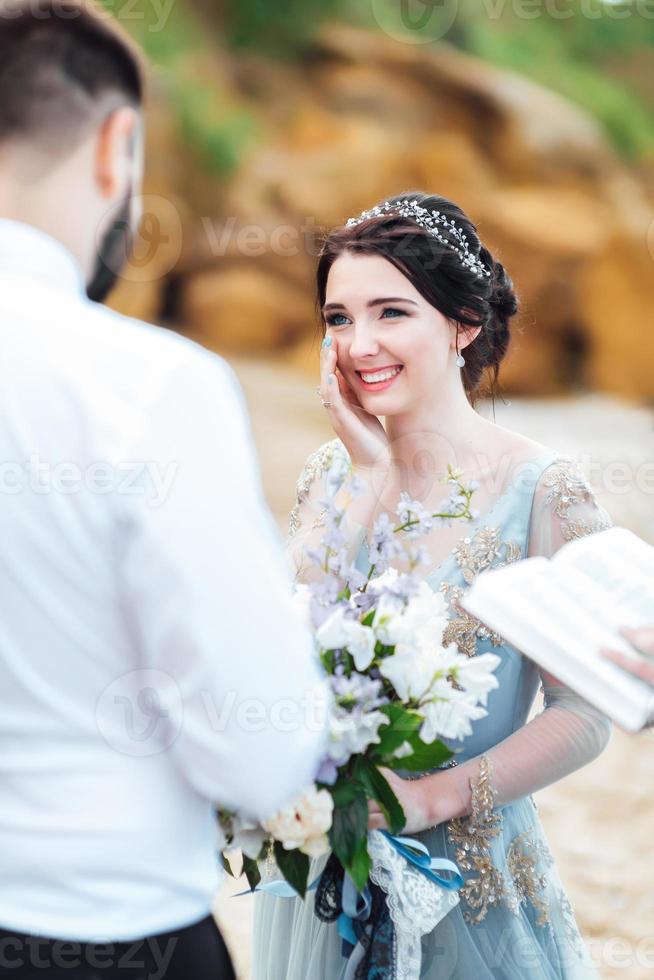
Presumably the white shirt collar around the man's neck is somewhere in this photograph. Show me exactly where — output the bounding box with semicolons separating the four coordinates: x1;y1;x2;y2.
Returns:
0;218;86;294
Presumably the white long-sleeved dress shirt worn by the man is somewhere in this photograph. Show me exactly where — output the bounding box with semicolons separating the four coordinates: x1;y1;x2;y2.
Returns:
0;220;327;941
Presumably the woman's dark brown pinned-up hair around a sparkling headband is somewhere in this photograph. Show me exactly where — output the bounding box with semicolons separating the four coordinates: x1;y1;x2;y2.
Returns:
316;191;518;404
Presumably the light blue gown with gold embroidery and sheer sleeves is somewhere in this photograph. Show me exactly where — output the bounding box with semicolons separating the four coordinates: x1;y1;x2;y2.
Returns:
252;440;610;980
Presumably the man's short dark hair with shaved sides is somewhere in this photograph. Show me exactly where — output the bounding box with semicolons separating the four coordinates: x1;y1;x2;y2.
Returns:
0;0;144;150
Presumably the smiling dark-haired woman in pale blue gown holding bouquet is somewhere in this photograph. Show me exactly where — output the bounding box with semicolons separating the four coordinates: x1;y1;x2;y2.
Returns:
253;193;610;980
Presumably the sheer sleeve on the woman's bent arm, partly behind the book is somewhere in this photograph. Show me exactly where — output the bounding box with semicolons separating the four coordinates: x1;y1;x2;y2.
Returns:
443;459;611;817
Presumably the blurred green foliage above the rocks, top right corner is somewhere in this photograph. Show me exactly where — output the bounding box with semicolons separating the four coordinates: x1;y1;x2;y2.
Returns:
358;0;654;158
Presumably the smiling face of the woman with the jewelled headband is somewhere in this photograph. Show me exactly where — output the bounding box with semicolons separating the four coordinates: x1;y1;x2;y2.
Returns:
323;252;456;416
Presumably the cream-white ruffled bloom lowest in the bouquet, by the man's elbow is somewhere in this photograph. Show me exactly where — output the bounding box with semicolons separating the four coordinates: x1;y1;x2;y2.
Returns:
263;786;334;857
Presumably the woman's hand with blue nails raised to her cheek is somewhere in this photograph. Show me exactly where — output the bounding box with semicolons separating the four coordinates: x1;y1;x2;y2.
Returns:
320;333;390;469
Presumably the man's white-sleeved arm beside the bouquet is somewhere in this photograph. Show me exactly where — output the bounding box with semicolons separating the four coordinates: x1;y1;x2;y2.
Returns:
118;351;327;817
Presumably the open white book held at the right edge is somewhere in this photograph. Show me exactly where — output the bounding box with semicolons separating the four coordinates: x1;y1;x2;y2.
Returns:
460;527;654;732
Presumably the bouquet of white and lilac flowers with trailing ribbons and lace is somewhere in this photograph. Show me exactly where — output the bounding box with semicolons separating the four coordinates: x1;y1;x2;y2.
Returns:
220;467;499;977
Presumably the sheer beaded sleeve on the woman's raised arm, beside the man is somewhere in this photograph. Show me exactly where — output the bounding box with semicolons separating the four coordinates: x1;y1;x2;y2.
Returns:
286;439;366;582
